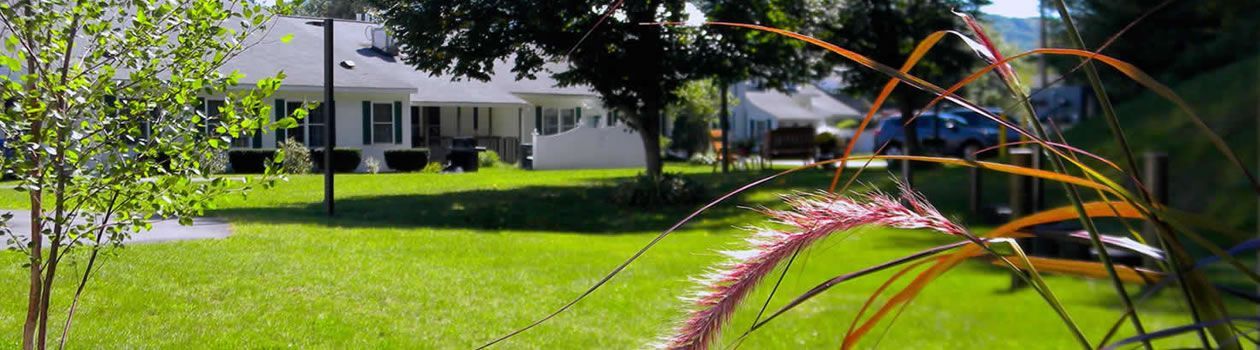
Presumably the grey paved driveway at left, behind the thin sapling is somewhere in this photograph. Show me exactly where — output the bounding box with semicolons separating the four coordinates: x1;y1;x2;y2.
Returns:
0;210;232;248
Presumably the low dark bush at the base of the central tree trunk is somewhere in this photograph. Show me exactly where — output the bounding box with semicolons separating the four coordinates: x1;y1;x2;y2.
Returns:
612;172;707;206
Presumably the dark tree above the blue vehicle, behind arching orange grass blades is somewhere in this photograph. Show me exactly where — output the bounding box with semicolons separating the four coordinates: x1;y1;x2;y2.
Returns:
819;0;988;183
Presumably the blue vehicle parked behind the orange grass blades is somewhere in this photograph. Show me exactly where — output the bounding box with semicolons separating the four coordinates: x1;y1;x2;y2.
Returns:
874;110;1019;159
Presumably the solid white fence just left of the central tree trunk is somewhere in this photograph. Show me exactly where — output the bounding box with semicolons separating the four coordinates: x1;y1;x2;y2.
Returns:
533;123;646;170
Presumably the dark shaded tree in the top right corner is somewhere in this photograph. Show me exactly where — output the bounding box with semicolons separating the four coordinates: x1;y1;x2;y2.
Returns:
1048;0;1260;98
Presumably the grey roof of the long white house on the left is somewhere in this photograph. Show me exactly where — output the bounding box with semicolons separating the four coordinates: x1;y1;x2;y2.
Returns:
224;16;595;104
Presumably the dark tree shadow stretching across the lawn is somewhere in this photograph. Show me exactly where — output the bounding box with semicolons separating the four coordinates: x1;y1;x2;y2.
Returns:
212;171;856;234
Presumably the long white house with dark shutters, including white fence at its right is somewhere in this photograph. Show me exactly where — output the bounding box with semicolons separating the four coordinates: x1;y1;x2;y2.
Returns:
211;16;643;167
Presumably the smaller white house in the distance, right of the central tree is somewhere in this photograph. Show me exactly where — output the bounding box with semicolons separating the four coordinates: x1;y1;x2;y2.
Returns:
731;82;869;151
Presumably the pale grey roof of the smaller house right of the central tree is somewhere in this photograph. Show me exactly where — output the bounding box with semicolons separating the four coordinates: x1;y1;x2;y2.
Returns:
745;84;862;121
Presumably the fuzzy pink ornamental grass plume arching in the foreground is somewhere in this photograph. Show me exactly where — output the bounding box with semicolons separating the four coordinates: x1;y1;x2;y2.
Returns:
664;186;964;349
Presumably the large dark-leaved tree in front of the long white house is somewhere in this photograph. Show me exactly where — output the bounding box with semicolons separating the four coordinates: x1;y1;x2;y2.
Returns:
375;0;826;176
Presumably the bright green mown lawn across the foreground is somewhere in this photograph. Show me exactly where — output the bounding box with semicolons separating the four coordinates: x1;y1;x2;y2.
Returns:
0;166;1219;349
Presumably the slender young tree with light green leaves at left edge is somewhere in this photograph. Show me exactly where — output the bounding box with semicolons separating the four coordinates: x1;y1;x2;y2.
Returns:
0;0;295;349
